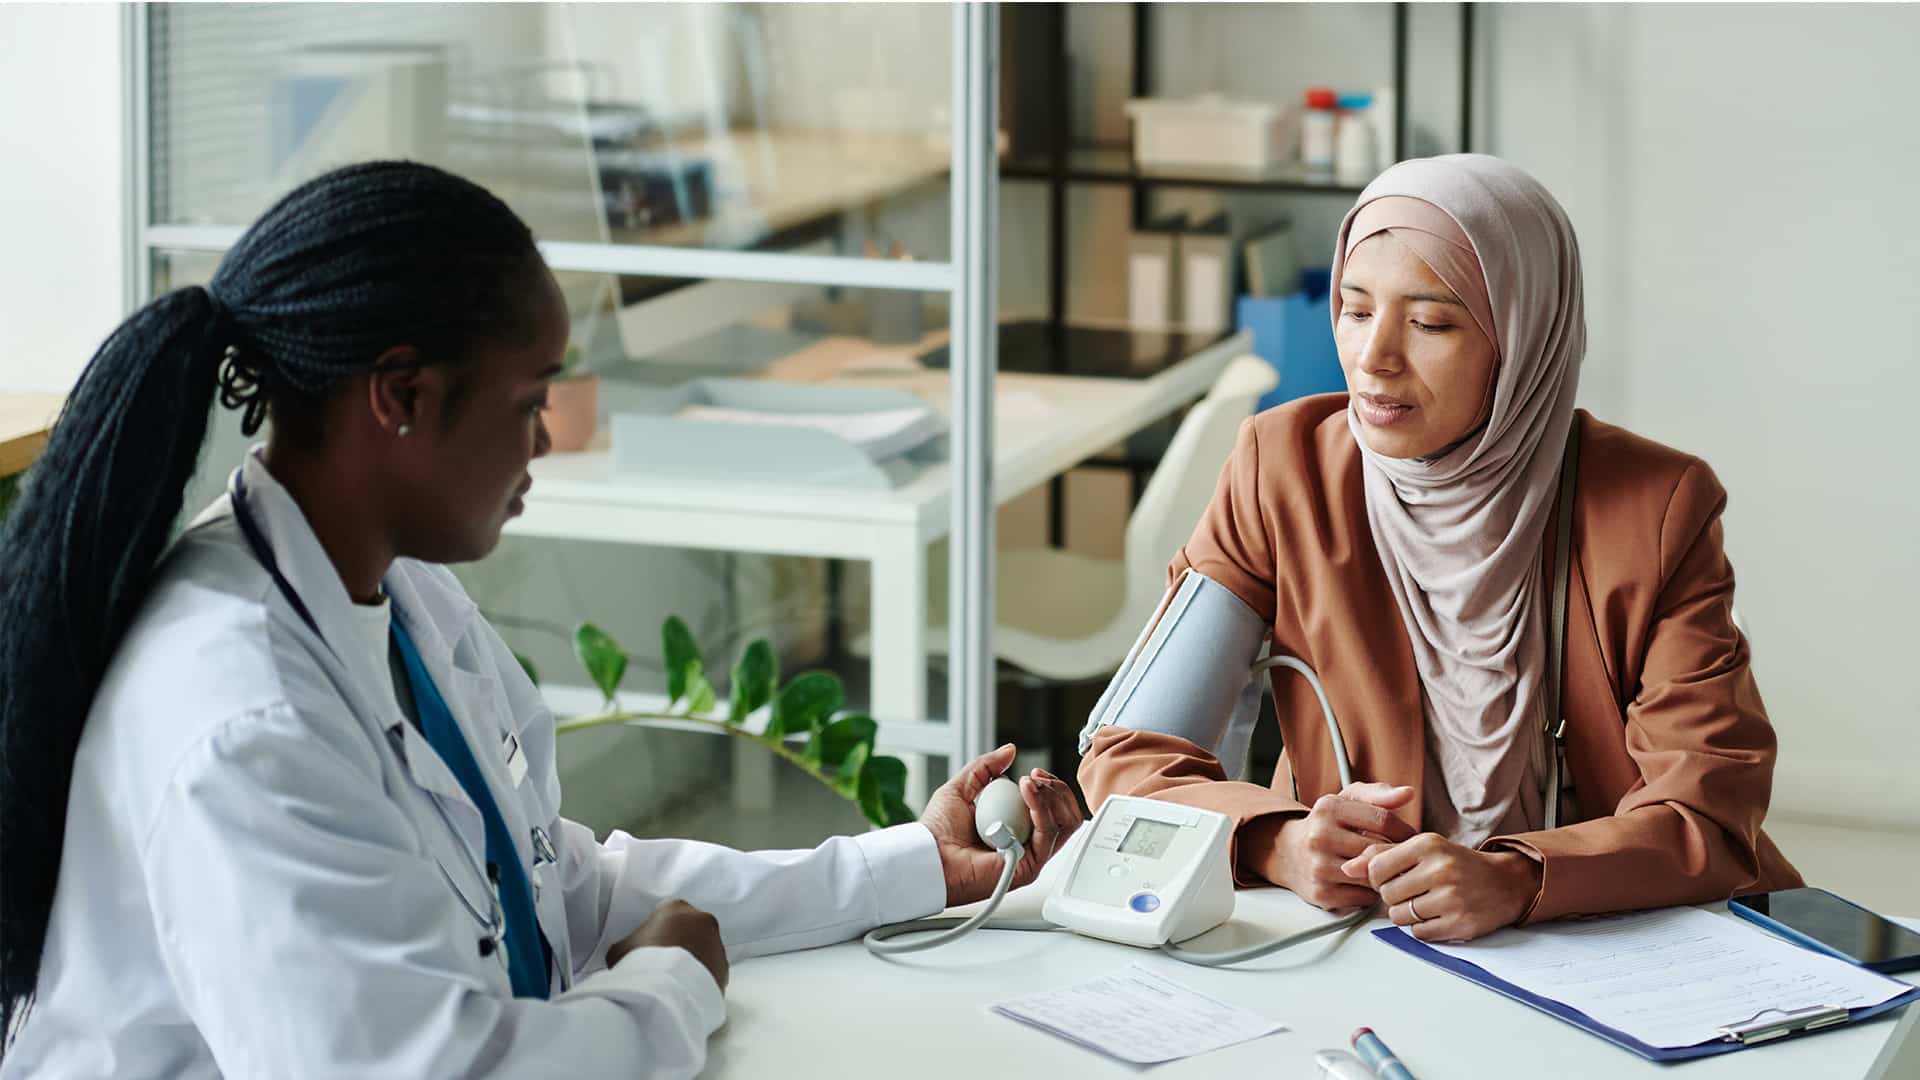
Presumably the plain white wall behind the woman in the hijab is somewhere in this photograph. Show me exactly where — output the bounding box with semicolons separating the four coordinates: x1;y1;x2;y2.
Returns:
1490;4;1920;826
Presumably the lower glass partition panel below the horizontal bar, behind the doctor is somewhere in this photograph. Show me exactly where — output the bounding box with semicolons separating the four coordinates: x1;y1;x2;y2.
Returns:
154;252;950;847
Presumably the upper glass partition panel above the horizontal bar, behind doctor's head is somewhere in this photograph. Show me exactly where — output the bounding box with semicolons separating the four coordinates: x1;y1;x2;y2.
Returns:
150;4;952;259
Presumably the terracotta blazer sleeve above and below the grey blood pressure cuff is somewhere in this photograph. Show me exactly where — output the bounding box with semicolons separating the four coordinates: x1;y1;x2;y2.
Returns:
1079;419;1308;886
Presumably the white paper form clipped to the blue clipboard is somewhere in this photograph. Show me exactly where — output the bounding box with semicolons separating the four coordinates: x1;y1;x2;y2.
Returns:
1432;907;1910;1047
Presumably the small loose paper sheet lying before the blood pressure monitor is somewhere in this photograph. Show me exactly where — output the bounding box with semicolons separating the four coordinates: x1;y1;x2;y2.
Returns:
993;965;1286;1065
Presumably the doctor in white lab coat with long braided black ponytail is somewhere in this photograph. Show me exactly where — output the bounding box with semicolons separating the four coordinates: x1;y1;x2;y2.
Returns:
0;155;1079;1080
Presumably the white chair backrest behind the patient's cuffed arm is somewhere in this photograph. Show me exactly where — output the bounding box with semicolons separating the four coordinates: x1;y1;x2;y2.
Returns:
1125;356;1281;614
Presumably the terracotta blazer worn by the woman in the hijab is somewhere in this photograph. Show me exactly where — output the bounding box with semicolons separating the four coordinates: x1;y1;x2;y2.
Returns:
1079;394;1801;922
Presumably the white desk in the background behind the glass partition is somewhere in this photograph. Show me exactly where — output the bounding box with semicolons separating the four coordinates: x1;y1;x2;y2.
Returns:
507;332;1252;755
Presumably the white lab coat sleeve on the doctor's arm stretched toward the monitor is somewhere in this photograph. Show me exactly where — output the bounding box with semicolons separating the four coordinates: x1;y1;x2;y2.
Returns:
555;819;947;974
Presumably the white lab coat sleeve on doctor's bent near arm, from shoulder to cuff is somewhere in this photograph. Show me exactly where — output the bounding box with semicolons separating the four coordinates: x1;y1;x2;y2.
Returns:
140;705;726;1080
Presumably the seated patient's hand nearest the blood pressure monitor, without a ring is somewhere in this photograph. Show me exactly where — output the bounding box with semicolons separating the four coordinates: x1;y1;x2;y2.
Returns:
1267;784;1413;911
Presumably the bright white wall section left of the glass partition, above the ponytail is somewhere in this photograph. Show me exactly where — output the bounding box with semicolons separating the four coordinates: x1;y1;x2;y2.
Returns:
0;4;125;392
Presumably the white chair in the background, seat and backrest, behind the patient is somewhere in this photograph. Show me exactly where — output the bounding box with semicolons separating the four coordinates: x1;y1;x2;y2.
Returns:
927;356;1279;682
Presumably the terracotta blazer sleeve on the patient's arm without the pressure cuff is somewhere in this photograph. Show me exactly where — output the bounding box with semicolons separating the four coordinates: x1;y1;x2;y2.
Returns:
1486;461;1776;924
